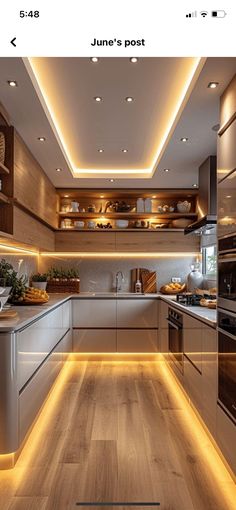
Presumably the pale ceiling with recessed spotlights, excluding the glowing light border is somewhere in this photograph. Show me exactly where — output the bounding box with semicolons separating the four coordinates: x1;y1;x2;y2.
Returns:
0;58;236;188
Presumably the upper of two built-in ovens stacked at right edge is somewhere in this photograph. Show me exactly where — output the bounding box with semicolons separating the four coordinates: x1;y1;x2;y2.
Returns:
218;234;236;312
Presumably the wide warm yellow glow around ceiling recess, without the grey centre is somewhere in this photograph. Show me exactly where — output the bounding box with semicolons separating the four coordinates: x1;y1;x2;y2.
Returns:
23;57;206;179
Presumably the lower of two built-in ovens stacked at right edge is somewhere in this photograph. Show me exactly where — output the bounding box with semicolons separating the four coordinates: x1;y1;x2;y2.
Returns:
218;309;236;423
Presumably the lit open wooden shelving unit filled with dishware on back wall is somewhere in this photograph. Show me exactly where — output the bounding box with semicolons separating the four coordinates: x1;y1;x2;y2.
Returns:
57;189;198;231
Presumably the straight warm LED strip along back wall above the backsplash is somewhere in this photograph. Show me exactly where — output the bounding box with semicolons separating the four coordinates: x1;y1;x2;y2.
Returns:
40;251;200;258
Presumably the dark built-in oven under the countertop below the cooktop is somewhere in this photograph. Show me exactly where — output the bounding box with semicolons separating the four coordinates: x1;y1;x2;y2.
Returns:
167;307;184;374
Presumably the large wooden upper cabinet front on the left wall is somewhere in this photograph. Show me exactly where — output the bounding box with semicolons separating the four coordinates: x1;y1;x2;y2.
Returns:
14;134;57;228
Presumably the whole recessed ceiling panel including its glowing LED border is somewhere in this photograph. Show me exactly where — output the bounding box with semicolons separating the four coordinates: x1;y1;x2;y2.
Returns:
24;58;205;178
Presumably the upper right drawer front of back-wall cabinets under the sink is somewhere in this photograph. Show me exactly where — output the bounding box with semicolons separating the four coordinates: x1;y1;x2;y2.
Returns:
117;298;158;328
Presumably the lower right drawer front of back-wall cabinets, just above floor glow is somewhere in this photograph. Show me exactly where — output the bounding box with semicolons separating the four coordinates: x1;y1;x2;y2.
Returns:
117;329;157;352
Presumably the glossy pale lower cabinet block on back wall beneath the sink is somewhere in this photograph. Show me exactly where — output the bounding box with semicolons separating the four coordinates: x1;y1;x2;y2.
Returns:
73;298;158;353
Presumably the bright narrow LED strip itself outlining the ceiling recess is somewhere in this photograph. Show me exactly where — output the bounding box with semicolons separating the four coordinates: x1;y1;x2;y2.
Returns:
23;57;206;178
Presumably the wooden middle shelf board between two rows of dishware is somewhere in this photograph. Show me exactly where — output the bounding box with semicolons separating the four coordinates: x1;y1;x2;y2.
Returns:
58;211;197;219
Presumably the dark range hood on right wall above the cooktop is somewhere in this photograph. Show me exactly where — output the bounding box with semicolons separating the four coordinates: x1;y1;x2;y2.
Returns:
184;156;217;235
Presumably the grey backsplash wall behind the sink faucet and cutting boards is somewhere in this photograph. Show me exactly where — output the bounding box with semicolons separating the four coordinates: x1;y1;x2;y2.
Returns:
39;256;195;292
